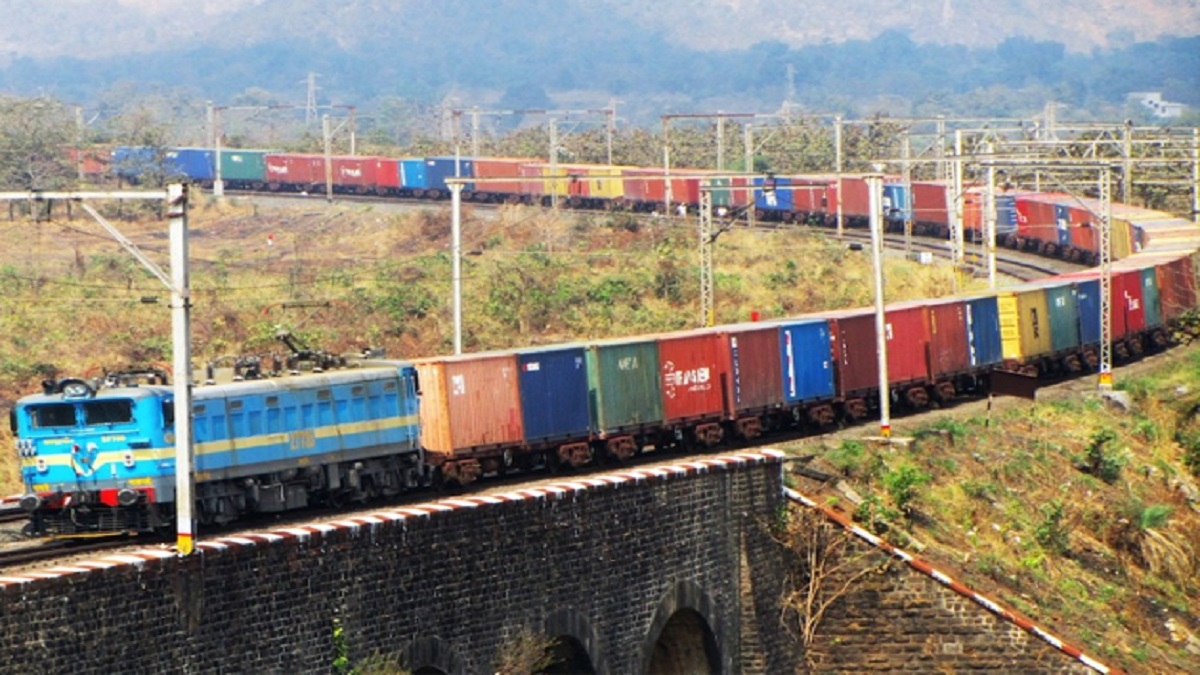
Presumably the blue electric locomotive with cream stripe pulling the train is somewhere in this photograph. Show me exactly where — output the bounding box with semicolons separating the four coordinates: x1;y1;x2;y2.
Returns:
11;362;428;536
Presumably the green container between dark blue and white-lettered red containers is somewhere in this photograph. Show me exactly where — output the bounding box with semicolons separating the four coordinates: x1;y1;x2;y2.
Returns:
587;339;662;434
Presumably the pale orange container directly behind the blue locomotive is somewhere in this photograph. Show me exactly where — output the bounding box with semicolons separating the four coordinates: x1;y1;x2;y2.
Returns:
413;352;523;458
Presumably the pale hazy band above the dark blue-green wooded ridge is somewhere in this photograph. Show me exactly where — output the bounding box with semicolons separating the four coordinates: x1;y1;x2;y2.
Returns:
0;0;1200;56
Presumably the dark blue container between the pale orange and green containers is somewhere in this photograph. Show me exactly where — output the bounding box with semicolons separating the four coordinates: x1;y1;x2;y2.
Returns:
517;347;592;443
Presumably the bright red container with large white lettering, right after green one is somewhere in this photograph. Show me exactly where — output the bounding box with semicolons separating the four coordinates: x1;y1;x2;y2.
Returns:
655;330;728;424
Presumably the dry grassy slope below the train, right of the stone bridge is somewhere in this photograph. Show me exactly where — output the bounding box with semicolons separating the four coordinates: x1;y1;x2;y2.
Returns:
793;344;1200;673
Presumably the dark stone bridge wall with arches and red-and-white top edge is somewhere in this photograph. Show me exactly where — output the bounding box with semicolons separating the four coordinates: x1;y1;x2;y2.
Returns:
0;453;798;674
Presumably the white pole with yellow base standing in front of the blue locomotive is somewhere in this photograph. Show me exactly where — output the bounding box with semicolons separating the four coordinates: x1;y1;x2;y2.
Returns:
167;183;196;556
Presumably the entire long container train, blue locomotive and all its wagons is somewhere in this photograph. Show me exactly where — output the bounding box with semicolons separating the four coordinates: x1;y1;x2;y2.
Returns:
10;144;1200;536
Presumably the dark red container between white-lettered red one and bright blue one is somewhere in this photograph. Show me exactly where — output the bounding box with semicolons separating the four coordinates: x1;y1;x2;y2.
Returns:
716;323;784;417
